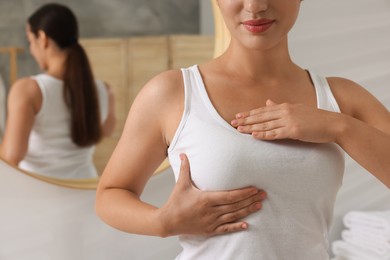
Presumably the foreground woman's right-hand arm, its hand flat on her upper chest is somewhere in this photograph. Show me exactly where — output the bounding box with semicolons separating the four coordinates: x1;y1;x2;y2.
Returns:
232;78;390;188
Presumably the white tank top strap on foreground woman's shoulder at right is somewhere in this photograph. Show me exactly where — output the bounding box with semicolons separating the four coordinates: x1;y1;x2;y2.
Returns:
309;71;341;113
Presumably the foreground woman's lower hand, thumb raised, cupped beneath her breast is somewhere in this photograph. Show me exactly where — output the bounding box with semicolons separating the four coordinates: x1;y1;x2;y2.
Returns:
158;154;266;237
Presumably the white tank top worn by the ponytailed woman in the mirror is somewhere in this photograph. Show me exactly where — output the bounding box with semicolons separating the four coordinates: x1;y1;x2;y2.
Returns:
19;74;108;179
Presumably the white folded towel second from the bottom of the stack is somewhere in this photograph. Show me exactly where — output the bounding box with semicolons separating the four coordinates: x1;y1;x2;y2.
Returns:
341;230;390;259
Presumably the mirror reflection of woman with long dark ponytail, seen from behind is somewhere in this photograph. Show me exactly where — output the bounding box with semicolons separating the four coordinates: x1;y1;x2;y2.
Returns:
0;4;115;178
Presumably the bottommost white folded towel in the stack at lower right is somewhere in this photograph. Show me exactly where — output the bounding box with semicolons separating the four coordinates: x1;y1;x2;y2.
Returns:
332;240;390;260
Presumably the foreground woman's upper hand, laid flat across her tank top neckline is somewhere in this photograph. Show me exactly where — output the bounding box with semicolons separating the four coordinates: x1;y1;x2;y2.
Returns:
231;100;342;143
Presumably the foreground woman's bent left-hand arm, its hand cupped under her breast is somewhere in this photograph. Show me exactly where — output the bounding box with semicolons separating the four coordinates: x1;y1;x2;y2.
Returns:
96;71;264;237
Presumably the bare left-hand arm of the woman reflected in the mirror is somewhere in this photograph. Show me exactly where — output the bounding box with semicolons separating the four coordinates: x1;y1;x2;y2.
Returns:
0;78;42;165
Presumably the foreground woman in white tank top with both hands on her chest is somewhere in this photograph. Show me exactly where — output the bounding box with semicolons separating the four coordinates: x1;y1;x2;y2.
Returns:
97;0;390;259
